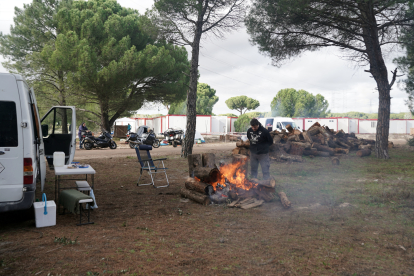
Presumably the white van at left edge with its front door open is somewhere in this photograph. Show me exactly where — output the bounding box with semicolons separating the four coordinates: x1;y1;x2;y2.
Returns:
0;73;76;212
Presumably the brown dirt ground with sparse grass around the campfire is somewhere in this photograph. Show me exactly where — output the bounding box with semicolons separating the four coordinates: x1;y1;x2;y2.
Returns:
0;145;414;276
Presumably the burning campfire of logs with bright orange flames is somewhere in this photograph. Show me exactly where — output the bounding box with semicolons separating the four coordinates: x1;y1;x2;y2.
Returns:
180;154;290;209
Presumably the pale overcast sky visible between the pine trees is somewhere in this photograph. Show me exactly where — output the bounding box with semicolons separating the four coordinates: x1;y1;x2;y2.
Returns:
0;0;408;114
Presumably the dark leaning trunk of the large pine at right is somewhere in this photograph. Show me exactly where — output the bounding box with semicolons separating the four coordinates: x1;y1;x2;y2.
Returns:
358;3;391;159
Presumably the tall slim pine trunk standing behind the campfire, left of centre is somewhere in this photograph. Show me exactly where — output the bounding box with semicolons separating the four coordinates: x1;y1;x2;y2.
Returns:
183;23;203;158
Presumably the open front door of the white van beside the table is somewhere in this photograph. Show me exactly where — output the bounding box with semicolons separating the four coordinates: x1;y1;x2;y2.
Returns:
41;106;77;166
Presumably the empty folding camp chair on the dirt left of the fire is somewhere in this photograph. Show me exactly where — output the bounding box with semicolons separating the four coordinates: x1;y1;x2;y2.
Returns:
135;145;170;188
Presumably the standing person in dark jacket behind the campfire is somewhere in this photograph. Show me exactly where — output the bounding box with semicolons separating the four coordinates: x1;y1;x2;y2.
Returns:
247;119;273;179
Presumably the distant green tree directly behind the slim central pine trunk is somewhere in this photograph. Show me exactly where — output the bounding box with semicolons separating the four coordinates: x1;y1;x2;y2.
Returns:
168;83;219;115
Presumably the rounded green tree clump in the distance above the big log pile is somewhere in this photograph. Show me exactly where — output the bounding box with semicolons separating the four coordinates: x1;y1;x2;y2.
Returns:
270;88;329;118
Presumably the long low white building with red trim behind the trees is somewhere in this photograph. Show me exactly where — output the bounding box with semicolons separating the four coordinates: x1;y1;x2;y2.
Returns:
115;115;414;135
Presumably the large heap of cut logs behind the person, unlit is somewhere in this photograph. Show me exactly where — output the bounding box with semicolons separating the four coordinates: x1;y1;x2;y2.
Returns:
270;123;375;164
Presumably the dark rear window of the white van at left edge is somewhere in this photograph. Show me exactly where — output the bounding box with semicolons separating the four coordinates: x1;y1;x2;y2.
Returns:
0;101;18;147
